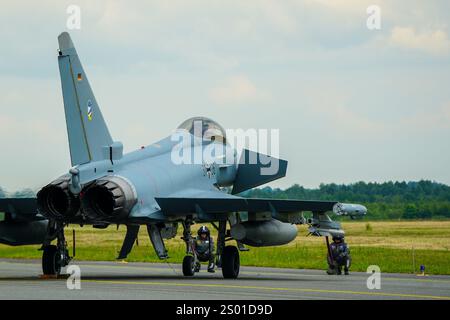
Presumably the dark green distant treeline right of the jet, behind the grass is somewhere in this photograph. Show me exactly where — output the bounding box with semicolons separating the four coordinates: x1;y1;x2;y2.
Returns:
242;180;450;220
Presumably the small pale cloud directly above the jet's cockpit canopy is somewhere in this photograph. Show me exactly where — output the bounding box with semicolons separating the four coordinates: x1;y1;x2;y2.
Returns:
210;75;266;104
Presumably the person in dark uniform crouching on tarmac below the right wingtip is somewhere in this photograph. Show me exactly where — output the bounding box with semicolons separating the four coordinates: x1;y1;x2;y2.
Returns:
327;235;352;275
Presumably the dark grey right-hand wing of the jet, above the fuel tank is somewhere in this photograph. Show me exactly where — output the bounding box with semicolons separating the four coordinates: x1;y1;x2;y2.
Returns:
156;196;337;215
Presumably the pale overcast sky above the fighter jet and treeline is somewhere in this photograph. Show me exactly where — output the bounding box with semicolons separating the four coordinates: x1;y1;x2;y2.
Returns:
0;0;450;191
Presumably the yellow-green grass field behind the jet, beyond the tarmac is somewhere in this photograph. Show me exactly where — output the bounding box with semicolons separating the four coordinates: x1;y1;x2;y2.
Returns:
0;221;450;274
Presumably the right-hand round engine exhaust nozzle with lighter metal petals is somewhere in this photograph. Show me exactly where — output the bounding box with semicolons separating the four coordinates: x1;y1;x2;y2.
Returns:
81;176;137;219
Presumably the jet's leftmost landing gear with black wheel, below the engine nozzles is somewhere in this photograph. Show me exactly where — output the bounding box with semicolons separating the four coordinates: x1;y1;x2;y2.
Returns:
41;222;71;275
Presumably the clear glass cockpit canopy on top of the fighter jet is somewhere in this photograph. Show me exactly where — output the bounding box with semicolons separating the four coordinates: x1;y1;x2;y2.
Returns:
178;117;226;143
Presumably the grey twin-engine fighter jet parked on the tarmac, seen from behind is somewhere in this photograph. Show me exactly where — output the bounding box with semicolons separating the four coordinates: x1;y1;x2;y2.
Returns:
0;32;367;278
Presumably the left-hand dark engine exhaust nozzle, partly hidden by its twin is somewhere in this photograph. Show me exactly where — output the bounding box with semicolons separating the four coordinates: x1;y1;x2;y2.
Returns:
37;176;80;219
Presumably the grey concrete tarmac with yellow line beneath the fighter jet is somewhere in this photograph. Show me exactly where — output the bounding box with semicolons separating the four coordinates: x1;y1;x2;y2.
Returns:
0;259;450;300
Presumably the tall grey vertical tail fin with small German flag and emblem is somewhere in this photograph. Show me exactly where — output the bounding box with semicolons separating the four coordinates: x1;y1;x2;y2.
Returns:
58;32;113;166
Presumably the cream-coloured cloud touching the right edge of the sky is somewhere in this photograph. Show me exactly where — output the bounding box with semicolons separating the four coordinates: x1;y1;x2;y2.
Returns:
389;27;450;55
